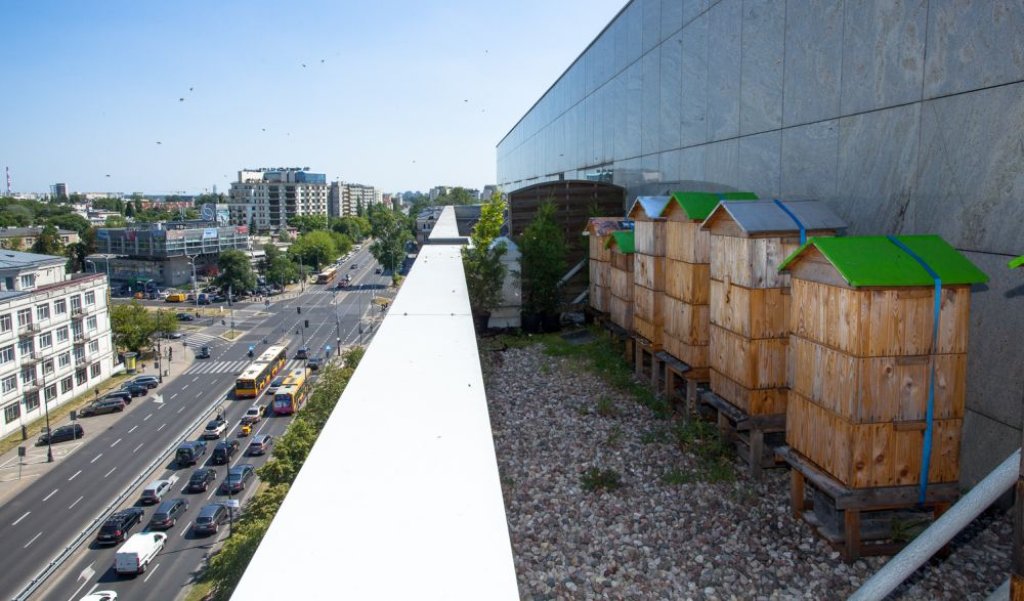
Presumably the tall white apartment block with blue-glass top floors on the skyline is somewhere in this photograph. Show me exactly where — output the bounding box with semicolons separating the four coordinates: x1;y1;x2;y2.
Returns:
228;167;329;231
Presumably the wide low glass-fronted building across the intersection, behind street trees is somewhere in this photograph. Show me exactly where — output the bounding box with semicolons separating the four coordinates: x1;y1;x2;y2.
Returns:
87;220;252;287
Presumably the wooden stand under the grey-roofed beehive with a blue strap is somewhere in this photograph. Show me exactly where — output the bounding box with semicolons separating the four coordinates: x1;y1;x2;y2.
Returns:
699;390;785;480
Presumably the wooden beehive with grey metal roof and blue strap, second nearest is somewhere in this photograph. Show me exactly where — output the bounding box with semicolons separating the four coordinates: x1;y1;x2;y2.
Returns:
700;201;846;416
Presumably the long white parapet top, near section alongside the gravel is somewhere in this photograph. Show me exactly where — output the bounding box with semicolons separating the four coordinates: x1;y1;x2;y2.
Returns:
232;245;519;601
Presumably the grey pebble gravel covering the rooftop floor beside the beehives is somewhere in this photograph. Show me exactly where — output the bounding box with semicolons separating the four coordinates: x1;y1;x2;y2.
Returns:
483;345;1013;600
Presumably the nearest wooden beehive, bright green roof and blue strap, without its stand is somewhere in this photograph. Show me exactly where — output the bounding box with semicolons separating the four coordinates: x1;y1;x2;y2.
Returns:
780;235;988;487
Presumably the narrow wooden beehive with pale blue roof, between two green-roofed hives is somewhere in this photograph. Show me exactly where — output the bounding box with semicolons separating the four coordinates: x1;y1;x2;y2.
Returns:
628;197;669;350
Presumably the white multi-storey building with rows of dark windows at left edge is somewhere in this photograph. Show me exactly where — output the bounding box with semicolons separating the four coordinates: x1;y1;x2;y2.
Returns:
0;251;114;436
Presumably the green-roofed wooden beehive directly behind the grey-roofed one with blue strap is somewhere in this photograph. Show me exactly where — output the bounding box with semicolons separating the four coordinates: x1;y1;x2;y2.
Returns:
662;191;757;382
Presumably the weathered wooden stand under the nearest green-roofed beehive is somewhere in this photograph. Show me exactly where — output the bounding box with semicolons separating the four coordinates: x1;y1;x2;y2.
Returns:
775;445;959;563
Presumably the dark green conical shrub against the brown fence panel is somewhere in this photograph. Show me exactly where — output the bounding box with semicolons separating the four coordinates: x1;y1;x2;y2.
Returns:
519;201;565;315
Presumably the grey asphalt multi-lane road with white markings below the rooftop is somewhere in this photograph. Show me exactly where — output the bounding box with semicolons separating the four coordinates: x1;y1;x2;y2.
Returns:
0;251;387;601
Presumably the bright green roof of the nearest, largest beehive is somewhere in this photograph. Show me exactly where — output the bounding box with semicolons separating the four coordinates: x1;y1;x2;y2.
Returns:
778;235;988;287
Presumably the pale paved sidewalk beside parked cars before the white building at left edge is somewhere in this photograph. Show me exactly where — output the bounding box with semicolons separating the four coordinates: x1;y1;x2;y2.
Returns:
0;340;196;504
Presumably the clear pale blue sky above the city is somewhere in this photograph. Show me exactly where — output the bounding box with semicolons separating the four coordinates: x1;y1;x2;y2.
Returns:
0;0;626;194
